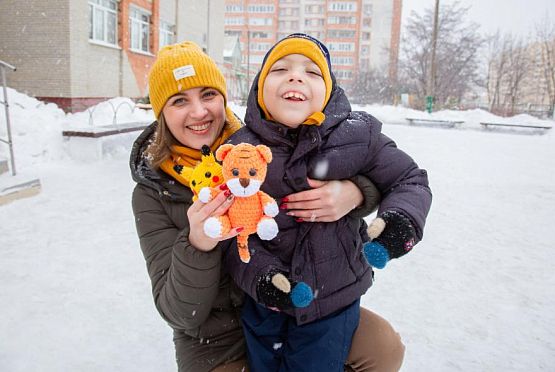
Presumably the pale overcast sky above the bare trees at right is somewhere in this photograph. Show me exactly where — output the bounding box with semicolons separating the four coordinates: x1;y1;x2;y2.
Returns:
403;0;555;36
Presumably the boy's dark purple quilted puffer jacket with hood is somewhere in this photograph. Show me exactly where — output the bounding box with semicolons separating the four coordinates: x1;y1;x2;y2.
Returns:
226;71;431;324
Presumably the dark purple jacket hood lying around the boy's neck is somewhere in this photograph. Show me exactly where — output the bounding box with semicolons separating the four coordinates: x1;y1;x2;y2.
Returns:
245;67;351;142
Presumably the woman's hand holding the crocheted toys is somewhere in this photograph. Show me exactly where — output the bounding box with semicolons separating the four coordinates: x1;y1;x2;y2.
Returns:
187;190;242;252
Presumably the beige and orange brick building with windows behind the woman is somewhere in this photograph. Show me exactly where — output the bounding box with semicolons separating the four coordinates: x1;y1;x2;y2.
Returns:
0;0;224;111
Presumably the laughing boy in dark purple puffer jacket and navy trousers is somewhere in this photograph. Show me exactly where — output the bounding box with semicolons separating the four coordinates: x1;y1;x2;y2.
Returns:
226;34;431;371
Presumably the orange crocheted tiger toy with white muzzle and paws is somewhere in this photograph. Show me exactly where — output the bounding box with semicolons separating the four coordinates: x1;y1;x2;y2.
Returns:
199;143;279;263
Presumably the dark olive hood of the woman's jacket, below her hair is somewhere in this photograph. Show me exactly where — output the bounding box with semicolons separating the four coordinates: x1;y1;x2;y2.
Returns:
129;121;193;200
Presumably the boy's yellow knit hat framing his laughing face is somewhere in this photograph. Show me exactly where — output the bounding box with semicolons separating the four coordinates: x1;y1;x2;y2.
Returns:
258;33;333;125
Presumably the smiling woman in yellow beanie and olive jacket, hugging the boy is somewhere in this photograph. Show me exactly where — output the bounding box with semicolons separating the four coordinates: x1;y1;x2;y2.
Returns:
130;42;404;371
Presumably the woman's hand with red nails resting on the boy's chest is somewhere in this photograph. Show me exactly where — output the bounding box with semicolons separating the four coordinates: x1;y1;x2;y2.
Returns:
280;178;364;222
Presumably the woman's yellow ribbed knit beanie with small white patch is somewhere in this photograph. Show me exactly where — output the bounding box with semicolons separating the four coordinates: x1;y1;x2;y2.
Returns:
148;41;227;118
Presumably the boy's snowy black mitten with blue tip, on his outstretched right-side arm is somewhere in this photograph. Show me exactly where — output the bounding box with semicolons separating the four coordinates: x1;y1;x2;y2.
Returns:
362;211;417;269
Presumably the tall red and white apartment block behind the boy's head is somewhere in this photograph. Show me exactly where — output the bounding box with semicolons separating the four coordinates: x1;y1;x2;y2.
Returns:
225;0;402;86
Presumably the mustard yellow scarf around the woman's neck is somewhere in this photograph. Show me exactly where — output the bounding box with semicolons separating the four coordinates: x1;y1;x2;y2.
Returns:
160;106;242;188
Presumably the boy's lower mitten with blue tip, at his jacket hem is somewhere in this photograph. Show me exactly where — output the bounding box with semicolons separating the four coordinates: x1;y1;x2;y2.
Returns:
256;269;314;310
